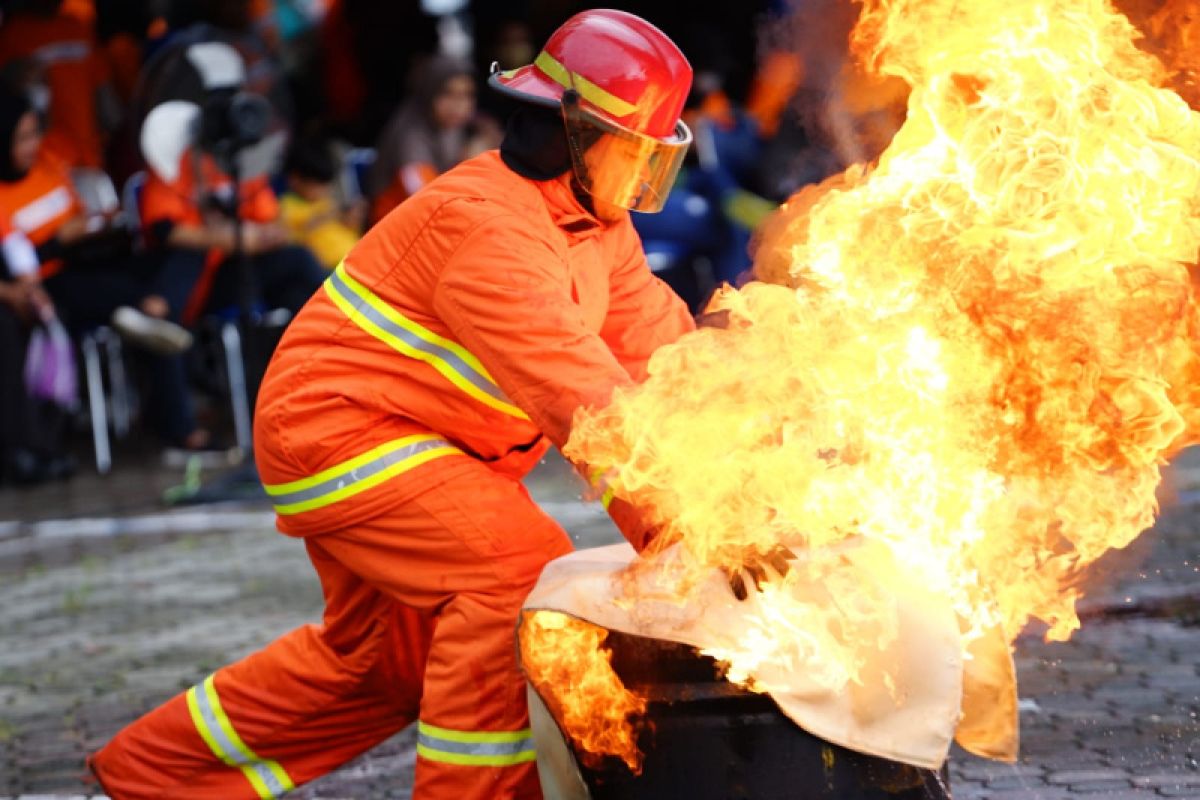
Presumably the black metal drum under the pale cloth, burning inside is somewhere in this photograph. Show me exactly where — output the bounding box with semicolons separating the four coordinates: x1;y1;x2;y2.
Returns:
529;631;950;800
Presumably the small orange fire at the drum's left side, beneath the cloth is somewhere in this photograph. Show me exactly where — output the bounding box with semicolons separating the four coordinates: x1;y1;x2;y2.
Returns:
518;610;646;775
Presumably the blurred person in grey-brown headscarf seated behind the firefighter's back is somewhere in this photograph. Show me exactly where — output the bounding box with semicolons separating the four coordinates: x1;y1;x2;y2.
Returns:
371;55;502;222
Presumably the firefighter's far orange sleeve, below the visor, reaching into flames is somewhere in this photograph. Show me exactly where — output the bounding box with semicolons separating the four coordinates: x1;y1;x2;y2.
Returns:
600;223;696;381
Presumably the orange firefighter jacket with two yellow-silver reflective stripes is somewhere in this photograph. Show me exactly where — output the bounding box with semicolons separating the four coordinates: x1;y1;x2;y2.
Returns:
256;151;692;535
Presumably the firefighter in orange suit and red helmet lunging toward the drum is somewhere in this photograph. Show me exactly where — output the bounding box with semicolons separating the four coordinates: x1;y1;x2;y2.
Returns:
90;11;694;800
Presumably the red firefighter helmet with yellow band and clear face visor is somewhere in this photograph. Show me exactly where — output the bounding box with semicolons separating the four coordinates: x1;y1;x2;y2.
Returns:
490;8;691;211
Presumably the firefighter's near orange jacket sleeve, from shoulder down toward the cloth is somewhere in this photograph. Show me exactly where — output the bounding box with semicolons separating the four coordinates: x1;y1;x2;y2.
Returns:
433;216;652;551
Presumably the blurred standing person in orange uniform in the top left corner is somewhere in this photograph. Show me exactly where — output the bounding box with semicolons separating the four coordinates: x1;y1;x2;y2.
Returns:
0;0;120;168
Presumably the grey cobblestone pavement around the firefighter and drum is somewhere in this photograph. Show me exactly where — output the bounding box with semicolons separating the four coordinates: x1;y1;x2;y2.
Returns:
0;453;1200;800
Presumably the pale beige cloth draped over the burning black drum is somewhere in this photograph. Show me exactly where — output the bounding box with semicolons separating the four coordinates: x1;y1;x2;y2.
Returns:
524;543;1018;769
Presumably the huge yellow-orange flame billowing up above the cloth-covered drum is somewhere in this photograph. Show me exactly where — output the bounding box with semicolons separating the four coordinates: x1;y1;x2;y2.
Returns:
566;0;1200;705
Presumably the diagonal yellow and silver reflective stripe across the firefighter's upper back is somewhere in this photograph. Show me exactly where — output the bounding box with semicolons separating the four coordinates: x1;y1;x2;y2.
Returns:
324;261;529;420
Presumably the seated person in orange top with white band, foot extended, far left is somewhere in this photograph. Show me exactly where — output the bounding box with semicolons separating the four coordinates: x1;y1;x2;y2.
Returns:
0;83;192;354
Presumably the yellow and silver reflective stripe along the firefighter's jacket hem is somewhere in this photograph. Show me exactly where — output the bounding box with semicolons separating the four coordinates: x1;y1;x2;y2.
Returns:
263;433;461;516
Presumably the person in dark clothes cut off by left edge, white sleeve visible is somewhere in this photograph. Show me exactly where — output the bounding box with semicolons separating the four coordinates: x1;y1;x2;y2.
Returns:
0;221;74;486
